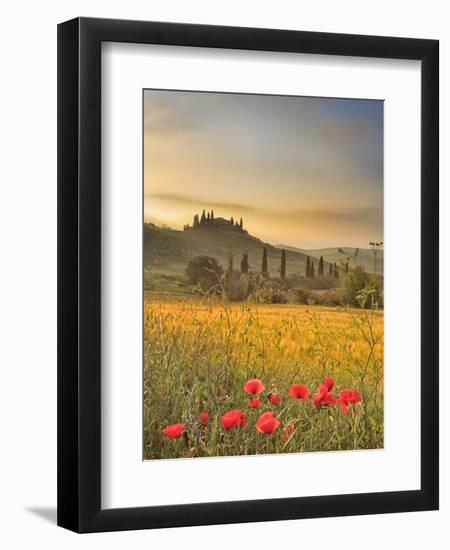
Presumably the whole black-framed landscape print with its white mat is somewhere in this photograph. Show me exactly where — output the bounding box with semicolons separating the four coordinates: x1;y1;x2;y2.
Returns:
58;18;439;532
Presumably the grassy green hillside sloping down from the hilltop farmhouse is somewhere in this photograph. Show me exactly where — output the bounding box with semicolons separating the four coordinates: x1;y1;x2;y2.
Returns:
144;222;326;276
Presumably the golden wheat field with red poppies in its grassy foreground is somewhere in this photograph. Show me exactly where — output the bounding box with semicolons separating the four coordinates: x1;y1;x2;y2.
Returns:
144;300;383;459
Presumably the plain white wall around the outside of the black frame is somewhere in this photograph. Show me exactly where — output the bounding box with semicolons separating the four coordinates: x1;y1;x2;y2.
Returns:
0;0;450;550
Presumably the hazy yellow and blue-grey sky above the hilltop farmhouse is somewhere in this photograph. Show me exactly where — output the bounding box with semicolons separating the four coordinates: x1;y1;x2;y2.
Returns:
144;90;383;248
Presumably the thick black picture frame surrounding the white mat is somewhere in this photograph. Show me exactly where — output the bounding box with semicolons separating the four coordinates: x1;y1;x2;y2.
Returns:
58;18;439;533
